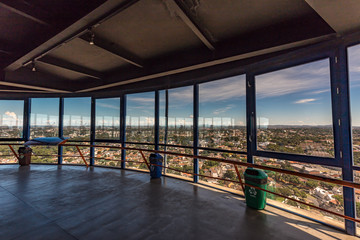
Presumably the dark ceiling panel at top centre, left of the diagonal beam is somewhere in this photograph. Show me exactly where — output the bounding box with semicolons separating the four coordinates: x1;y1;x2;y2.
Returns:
95;0;203;59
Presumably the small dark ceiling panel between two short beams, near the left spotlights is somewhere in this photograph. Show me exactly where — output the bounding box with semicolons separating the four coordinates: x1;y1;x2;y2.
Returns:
49;38;128;72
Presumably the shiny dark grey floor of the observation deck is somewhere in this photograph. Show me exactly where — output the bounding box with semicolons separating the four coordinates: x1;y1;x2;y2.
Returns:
0;165;357;240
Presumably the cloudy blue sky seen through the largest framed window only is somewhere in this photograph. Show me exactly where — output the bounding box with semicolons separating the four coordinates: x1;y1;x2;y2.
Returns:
255;59;332;126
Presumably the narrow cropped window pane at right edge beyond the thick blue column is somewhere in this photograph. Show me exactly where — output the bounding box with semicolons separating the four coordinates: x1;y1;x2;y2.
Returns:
348;45;360;165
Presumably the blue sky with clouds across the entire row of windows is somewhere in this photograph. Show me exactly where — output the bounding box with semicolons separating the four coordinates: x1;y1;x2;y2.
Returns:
0;46;360;126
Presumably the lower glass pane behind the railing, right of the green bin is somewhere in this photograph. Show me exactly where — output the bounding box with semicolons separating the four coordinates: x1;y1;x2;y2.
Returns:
254;157;344;228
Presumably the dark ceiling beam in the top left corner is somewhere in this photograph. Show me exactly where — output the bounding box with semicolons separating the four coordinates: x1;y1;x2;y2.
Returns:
0;0;50;26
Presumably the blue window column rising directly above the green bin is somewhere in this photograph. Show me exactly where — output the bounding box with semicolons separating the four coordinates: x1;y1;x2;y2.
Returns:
246;74;256;163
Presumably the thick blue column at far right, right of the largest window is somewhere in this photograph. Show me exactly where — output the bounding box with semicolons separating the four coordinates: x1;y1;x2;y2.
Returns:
331;46;356;235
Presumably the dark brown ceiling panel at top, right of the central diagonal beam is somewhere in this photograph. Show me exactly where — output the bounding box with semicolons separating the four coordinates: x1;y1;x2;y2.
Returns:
183;0;331;41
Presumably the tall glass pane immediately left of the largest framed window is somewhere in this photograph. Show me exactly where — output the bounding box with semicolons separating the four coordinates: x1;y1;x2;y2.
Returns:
199;75;246;151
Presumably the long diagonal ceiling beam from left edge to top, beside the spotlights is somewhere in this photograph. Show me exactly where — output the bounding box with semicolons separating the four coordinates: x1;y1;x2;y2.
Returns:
5;0;139;71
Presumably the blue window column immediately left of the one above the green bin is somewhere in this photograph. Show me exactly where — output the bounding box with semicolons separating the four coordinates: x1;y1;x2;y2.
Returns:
193;84;199;183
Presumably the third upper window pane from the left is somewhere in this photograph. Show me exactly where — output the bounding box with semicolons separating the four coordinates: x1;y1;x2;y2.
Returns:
63;98;91;141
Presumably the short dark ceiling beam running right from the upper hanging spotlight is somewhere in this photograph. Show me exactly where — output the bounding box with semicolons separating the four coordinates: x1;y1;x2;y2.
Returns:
80;34;144;68
